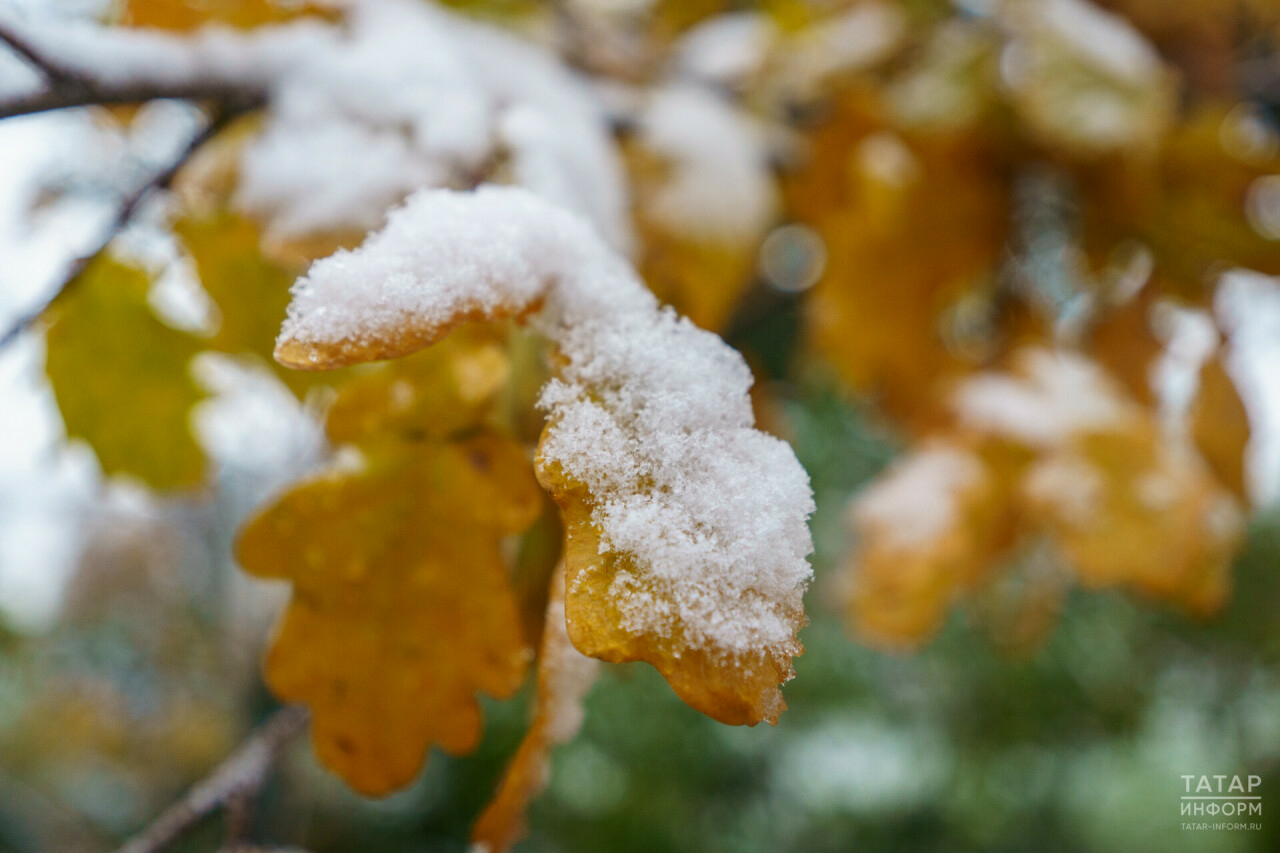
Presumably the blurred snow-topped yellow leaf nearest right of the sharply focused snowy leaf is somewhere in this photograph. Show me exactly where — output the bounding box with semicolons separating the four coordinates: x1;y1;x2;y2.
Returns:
849;441;1010;647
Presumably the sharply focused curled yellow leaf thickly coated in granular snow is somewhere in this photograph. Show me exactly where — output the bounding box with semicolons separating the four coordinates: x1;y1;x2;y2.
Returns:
276;187;813;724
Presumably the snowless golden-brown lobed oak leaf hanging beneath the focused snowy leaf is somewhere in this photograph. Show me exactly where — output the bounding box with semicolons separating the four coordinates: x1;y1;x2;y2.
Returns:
237;432;541;795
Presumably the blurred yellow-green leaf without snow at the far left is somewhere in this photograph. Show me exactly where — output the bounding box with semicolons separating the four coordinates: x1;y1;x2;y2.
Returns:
45;255;205;489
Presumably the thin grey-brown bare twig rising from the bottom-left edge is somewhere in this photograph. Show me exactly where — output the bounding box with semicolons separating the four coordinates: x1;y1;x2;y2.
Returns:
115;706;307;853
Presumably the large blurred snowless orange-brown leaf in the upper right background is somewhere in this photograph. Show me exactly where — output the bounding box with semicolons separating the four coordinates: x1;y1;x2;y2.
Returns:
787;95;1009;423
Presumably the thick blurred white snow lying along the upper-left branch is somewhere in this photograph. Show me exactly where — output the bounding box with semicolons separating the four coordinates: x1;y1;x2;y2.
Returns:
0;0;630;248
